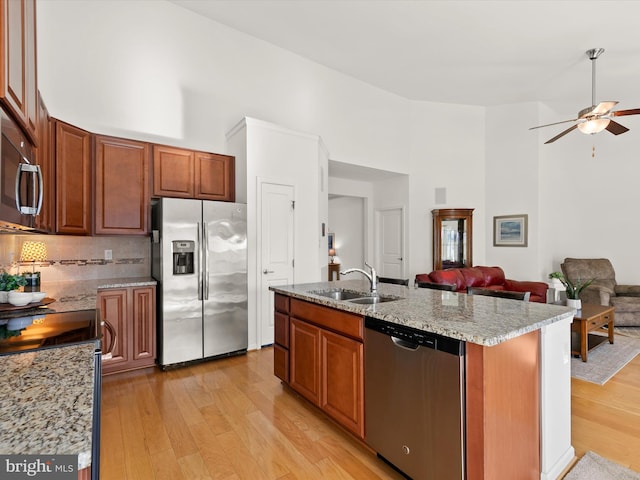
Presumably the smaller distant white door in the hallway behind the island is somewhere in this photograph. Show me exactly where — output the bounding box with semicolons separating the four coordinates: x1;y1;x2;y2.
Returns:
376;208;404;278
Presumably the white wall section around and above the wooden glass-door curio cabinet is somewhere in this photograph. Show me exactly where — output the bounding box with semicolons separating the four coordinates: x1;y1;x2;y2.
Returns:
407;102;487;278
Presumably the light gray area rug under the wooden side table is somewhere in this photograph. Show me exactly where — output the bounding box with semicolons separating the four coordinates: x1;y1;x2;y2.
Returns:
571;335;640;385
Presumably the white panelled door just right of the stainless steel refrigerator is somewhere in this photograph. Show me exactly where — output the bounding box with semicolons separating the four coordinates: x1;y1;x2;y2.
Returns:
258;182;294;345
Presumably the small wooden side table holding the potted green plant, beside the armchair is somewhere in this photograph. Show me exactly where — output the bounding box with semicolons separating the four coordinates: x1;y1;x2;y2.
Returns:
571;304;615;362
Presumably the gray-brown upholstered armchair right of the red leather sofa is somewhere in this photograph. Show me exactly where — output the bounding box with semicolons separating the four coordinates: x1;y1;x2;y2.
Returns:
561;258;640;327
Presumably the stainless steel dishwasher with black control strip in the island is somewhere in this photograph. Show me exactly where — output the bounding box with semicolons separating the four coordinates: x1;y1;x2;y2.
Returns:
364;317;465;480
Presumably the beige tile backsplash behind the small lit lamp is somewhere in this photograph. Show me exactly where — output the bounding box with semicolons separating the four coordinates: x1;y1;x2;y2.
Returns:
0;234;151;282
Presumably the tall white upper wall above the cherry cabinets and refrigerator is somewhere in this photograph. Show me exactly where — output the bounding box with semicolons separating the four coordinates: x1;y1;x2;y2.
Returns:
37;0;410;170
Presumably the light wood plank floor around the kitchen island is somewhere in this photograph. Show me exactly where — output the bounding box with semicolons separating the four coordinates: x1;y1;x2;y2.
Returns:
100;348;640;480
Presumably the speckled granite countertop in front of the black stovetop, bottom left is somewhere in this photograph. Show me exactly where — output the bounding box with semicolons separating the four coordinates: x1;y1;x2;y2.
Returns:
0;342;96;469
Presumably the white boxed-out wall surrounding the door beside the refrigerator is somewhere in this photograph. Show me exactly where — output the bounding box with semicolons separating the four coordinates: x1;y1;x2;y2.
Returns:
228;118;328;349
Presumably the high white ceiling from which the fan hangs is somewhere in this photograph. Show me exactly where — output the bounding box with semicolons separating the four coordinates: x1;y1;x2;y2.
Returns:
173;0;640;113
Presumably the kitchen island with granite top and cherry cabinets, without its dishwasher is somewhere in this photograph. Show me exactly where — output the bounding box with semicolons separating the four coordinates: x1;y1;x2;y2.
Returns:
271;280;574;479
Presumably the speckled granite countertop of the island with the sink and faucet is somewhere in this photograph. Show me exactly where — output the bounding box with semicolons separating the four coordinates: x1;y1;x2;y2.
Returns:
270;279;575;346
